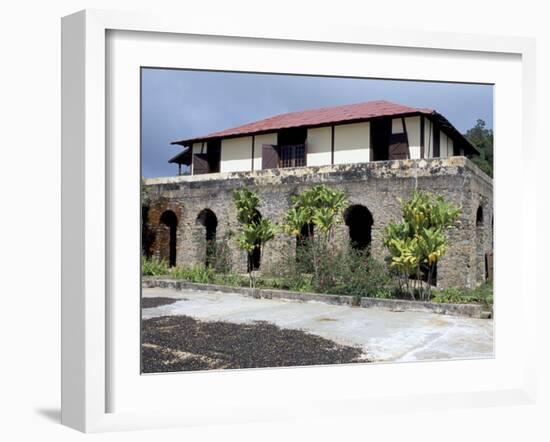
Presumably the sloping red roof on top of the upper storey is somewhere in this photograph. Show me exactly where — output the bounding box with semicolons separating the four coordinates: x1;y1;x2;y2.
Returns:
172;100;435;146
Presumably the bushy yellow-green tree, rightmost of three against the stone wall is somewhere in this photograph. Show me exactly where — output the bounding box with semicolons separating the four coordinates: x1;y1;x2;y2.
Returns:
384;191;461;299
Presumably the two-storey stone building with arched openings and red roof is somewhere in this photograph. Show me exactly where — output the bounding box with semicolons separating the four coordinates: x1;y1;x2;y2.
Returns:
143;101;493;288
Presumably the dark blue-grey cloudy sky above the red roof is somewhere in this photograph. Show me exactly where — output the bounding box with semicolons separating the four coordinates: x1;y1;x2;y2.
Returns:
141;68;493;178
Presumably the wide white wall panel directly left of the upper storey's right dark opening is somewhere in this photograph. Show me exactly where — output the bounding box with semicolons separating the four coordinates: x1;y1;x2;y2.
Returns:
334;121;370;164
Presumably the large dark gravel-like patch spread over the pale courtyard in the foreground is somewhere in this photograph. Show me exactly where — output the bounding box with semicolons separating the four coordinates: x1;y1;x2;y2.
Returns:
141;316;365;373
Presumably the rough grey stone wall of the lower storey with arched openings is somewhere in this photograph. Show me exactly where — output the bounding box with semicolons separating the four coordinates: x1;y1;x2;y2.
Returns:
145;157;493;288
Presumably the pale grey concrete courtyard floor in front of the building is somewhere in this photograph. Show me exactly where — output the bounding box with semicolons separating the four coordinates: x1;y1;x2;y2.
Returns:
142;288;494;362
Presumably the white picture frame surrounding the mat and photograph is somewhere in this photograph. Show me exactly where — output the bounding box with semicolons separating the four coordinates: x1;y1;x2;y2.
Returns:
62;10;536;432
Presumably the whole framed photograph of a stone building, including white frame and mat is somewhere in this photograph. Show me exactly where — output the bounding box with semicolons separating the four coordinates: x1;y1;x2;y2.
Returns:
62;11;536;432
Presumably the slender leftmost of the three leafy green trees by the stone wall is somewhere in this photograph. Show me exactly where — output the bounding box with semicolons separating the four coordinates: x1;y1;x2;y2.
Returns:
233;188;277;288
